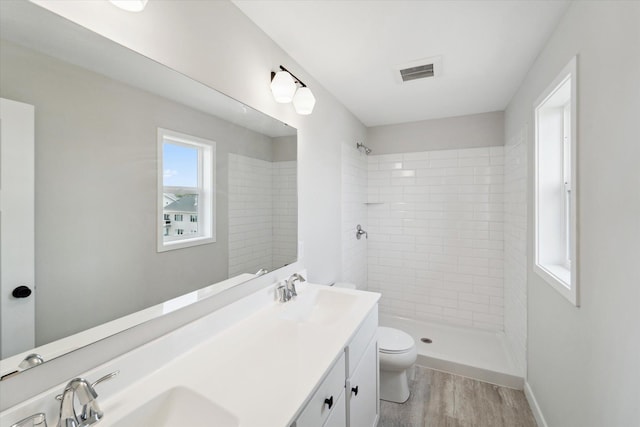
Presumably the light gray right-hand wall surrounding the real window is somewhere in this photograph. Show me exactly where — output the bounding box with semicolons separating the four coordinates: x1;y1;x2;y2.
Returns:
505;1;640;427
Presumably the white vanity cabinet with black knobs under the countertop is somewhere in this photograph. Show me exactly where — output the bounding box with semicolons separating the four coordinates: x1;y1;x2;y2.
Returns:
292;307;380;427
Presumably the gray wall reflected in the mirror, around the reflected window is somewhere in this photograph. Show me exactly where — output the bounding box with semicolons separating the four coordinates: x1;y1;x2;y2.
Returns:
0;42;280;345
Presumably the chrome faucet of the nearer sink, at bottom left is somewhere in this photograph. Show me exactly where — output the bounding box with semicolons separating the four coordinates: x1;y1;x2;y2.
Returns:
56;371;119;427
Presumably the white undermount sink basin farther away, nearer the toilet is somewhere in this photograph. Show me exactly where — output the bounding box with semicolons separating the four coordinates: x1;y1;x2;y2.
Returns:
280;287;357;325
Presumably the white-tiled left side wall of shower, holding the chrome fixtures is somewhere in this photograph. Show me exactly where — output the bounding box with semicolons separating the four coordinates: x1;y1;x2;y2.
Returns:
340;145;370;289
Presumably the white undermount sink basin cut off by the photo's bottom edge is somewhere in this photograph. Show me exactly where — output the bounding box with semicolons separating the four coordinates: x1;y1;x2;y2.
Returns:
111;387;239;427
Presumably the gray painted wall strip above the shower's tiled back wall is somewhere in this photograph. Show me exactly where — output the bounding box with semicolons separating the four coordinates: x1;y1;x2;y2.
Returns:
366;111;504;154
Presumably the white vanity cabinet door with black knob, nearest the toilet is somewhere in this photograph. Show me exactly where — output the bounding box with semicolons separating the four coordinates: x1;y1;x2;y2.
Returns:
345;338;379;427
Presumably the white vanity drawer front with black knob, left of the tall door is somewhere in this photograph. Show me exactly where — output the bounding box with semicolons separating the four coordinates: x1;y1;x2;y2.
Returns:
296;353;345;427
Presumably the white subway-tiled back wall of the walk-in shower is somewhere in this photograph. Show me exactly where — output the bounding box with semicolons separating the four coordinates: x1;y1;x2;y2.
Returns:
363;147;505;331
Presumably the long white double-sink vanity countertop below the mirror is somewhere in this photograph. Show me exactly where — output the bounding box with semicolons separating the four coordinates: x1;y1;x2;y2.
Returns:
0;283;380;427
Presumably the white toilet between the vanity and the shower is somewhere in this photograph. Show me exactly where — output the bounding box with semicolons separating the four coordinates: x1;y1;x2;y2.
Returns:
334;282;418;403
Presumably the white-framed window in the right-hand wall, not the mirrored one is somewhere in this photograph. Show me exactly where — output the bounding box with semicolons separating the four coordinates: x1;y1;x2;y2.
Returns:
534;57;579;306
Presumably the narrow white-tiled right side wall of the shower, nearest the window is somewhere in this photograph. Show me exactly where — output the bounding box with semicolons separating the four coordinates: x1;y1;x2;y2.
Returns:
504;127;527;375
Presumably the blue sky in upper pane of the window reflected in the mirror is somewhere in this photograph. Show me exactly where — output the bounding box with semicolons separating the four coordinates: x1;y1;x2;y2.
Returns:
162;142;198;187
